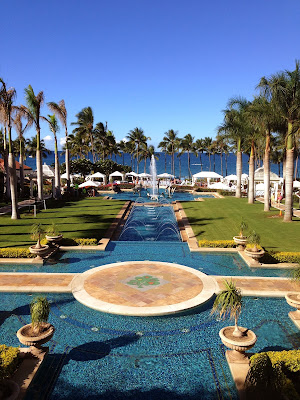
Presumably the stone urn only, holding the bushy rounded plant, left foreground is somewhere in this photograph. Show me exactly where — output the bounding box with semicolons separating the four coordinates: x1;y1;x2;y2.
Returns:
17;322;55;354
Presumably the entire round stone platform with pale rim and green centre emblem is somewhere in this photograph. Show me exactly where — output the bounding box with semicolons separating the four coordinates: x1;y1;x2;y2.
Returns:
72;261;216;316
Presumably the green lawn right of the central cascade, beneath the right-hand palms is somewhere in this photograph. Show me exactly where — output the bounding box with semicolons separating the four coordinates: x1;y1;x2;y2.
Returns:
182;198;300;251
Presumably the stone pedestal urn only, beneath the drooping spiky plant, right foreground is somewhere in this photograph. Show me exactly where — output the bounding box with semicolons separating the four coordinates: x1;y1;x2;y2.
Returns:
219;326;257;364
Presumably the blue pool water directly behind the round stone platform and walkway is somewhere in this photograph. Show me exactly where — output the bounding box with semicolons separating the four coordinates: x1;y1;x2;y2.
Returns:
0;241;288;277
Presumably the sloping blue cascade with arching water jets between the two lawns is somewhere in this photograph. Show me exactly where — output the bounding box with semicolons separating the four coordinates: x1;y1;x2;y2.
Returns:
119;205;181;242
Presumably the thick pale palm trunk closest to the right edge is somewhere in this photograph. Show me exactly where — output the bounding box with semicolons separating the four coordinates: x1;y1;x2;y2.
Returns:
283;122;294;222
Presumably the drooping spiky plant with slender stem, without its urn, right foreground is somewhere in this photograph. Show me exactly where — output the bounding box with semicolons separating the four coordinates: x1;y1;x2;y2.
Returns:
211;280;243;337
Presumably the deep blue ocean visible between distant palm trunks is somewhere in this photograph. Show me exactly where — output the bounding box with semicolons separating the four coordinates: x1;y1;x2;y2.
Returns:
25;151;282;179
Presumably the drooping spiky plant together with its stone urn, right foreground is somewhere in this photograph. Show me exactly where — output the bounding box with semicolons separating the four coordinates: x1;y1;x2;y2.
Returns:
212;280;257;363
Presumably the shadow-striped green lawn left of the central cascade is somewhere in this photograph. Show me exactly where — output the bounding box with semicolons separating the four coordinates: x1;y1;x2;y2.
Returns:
0;197;124;247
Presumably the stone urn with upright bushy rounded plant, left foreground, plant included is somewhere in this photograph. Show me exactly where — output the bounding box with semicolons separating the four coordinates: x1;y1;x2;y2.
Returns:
17;296;55;352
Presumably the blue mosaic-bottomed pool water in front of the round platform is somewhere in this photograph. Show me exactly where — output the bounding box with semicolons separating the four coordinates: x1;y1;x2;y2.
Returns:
0;293;300;400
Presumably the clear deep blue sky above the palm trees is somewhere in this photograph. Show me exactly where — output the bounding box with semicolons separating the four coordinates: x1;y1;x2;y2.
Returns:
0;0;300;148
